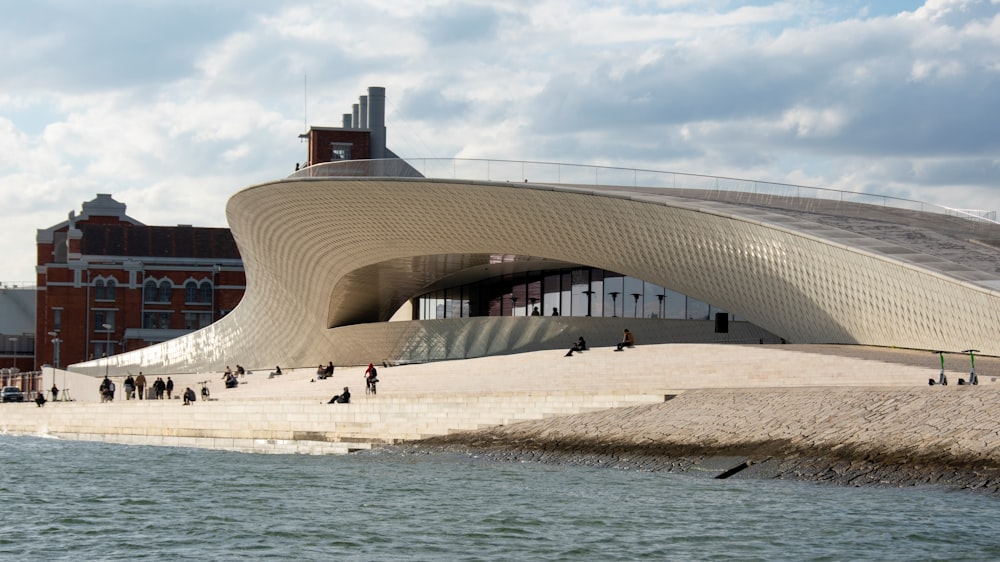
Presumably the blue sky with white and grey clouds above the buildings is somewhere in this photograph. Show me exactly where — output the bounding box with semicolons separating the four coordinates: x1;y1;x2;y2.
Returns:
0;0;1000;283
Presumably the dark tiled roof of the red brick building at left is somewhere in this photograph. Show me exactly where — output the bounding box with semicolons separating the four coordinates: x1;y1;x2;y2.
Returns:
79;224;240;259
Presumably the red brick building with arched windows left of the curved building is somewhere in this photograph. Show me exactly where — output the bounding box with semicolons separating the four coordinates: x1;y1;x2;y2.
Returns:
35;194;246;367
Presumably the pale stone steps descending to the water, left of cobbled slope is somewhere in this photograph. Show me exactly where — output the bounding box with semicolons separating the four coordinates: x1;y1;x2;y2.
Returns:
0;392;663;454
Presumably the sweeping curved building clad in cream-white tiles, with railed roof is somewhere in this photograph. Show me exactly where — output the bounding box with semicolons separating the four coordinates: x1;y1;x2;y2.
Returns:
73;160;1000;373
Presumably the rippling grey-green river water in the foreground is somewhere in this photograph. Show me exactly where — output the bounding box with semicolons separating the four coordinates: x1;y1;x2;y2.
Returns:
0;435;1000;561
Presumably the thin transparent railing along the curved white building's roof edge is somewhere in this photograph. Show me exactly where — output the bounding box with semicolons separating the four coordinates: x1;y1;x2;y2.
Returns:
288;158;1000;225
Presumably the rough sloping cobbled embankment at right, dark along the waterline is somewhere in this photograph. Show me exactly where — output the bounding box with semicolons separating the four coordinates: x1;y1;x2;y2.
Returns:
422;385;1000;493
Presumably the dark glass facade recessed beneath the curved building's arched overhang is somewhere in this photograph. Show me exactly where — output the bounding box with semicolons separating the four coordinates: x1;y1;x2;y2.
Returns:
416;267;738;320
